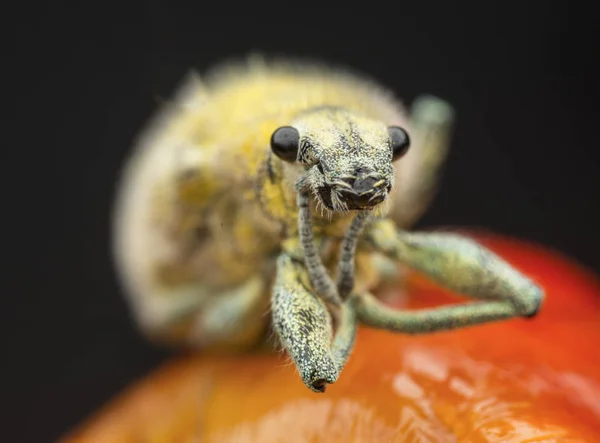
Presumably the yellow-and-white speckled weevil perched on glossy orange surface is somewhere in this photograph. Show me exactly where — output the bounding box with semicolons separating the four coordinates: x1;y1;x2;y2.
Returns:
113;57;544;392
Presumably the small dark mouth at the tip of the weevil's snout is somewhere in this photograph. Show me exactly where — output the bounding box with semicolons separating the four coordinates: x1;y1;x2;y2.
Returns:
340;171;391;209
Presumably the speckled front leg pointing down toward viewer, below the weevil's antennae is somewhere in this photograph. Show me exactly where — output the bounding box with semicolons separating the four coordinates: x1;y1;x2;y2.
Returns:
272;254;356;392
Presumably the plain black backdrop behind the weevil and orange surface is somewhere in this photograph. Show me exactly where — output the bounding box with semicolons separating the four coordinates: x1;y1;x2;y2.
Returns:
5;1;600;442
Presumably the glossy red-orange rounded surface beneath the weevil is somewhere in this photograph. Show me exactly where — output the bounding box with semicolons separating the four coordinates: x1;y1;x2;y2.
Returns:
63;235;600;443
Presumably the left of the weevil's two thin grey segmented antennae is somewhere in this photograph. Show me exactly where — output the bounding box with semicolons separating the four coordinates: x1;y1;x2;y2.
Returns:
298;192;342;306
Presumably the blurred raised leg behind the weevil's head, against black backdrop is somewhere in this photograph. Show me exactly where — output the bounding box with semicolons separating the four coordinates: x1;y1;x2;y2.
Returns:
388;95;454;227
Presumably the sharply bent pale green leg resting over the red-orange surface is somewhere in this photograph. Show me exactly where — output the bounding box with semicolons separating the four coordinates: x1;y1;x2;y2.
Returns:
357;220;544;333
